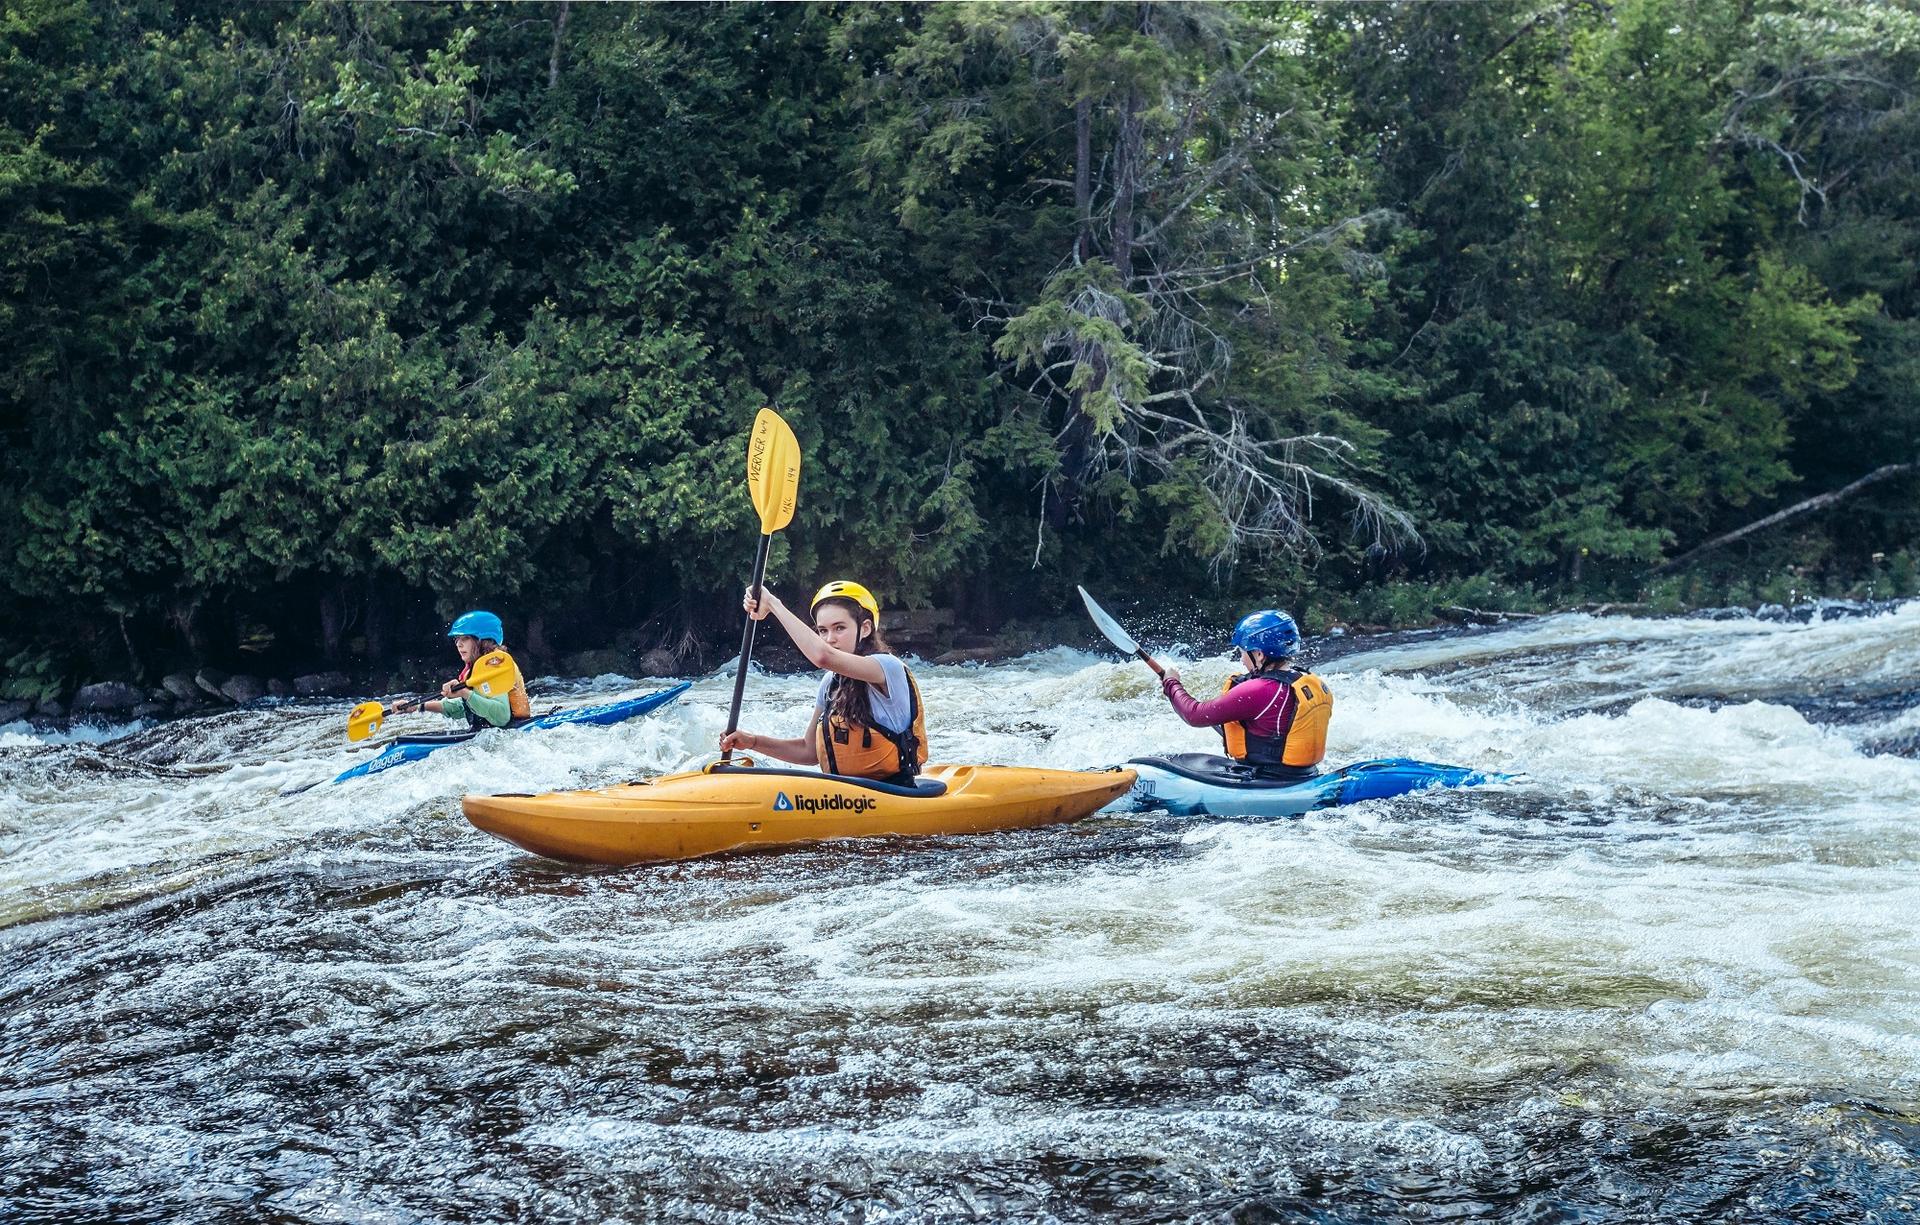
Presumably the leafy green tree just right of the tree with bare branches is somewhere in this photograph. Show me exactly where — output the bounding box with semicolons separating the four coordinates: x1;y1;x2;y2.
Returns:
1323;0;1878;591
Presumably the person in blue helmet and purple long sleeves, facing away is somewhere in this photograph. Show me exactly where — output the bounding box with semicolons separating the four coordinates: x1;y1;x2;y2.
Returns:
1160;609;1332;780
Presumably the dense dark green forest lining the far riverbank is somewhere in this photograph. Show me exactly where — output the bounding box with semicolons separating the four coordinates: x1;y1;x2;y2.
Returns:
0;0;1920;699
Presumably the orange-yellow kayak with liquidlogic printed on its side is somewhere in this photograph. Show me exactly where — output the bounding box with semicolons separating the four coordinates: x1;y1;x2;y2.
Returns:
461;764;1135;864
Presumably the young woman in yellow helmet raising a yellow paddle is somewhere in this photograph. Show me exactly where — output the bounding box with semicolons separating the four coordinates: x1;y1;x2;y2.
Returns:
720;580;927;785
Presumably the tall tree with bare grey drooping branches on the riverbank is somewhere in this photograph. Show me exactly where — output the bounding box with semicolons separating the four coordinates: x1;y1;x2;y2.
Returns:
862;4;1411;579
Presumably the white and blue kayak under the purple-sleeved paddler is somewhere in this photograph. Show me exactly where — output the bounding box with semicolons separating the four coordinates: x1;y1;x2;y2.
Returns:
1114;753;1515;816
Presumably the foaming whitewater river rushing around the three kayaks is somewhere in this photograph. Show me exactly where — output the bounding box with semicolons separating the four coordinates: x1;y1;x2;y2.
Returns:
0;603;1920;1225
